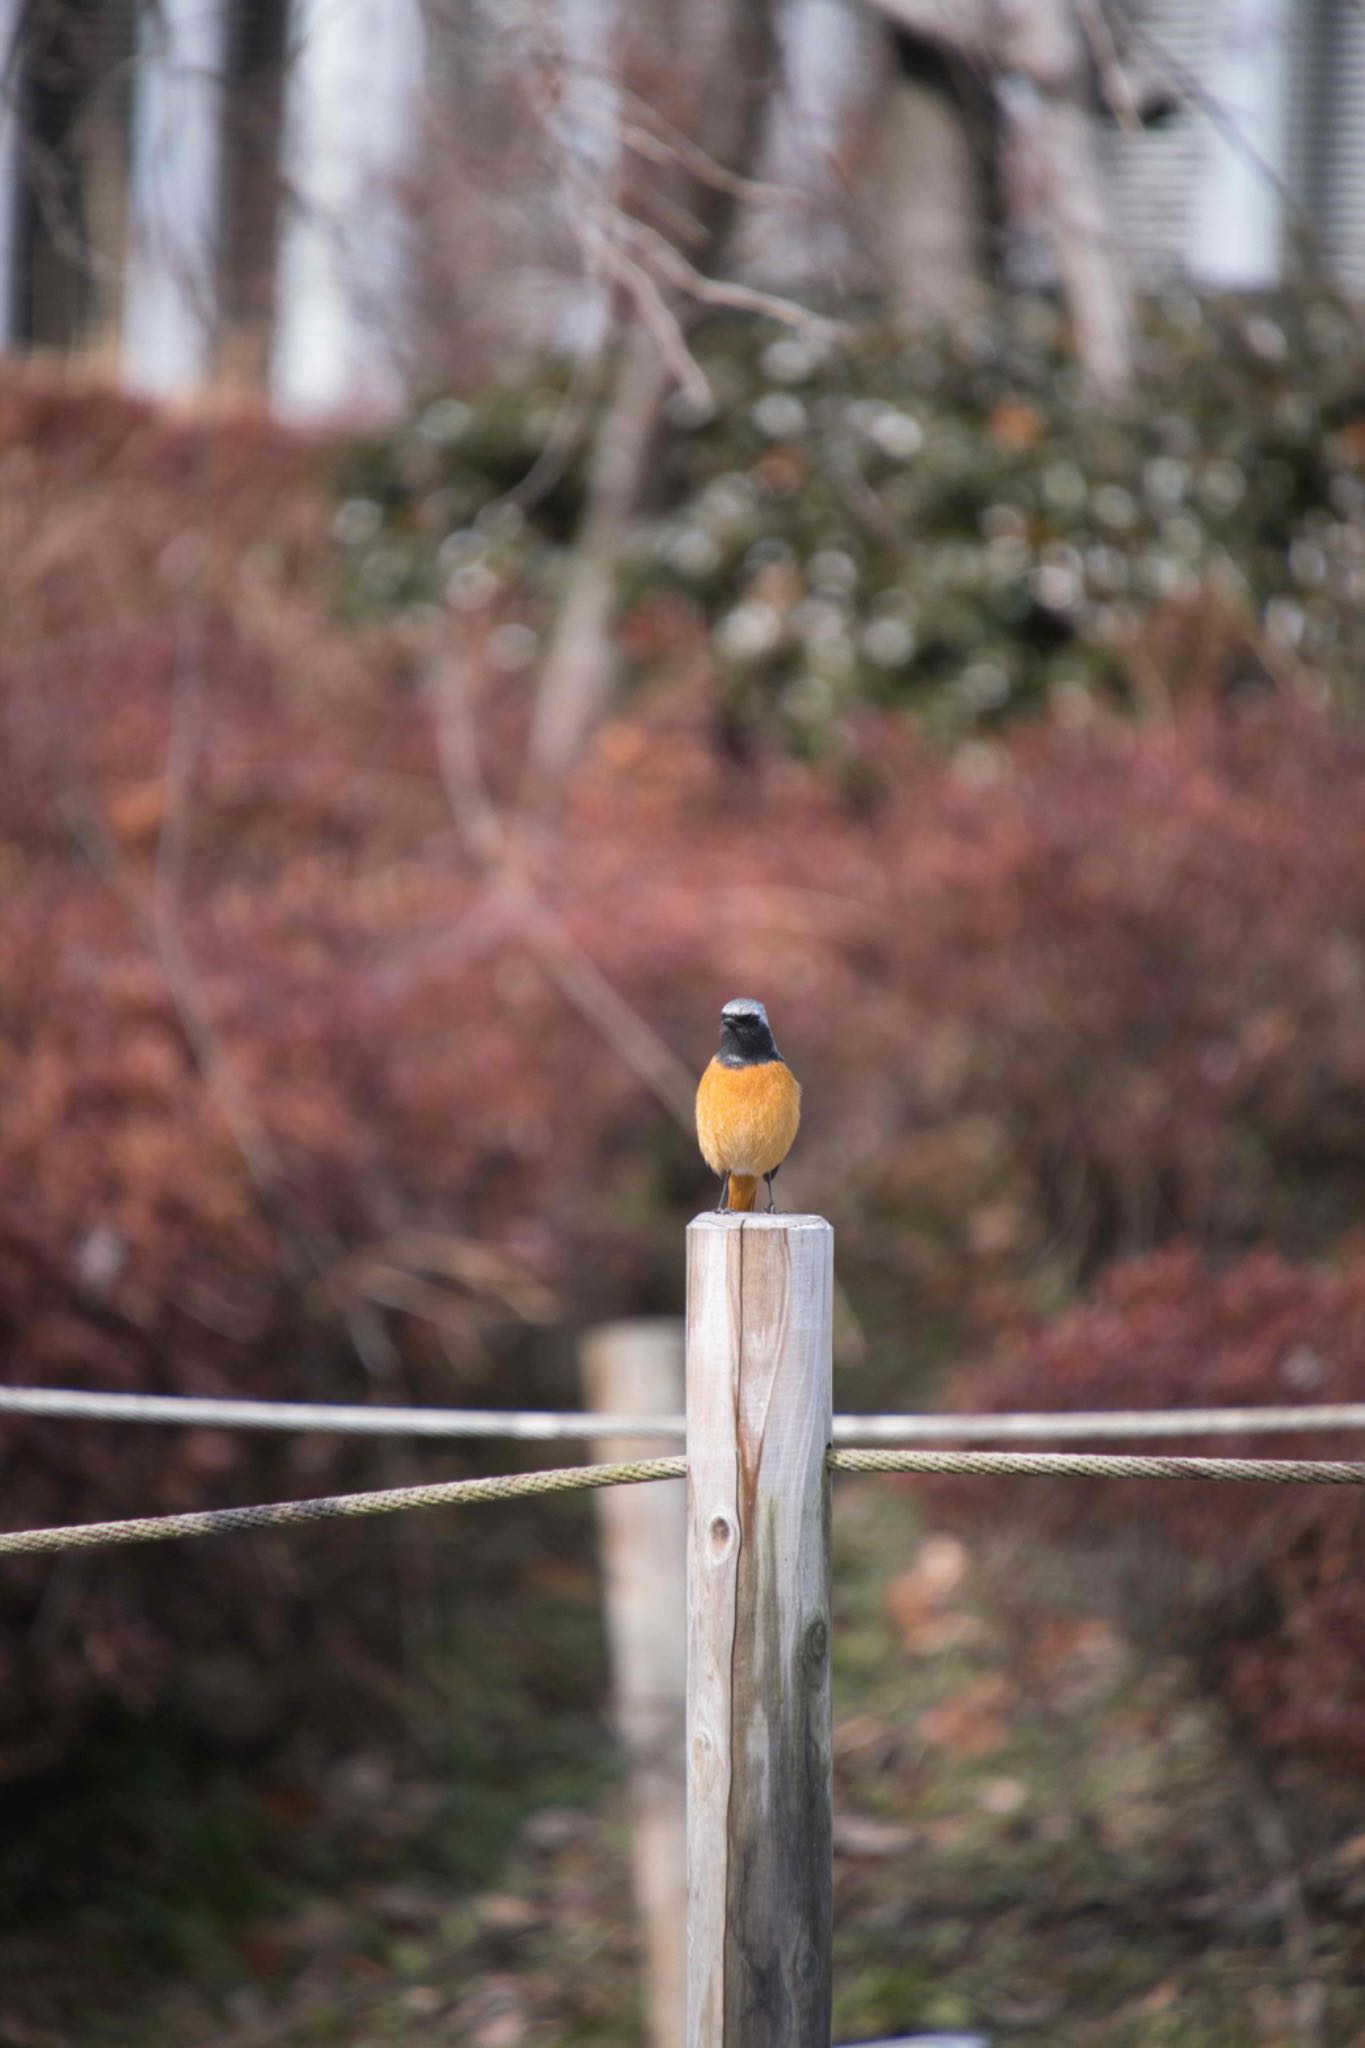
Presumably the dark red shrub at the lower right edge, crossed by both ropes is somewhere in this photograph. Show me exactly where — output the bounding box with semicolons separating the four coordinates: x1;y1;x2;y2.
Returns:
948;1239;1365;1767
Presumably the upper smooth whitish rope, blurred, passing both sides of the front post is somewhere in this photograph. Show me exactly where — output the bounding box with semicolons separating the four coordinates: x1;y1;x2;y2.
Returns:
0;1386;1365;1444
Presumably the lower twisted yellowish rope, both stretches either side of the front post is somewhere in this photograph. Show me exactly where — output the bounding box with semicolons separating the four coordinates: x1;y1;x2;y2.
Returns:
0;1450;1365;1559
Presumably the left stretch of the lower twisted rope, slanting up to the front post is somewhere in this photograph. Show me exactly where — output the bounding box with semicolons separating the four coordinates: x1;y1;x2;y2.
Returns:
0;1458;688;1556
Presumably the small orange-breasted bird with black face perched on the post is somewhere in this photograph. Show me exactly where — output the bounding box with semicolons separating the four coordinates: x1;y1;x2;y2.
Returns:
696;995;800;1214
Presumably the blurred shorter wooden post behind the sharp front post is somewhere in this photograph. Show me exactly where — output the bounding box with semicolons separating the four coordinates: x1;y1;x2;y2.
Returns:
579;1321;688;2048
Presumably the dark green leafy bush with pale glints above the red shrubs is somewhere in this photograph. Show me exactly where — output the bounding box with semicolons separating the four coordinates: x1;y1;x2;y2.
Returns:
336;287;1365;752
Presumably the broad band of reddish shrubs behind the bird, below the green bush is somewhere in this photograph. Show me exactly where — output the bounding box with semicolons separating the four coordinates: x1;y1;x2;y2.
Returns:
0;385;1365;1769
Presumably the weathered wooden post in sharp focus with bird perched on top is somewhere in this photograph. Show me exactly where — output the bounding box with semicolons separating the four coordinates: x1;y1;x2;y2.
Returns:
688;1214;833;2048
